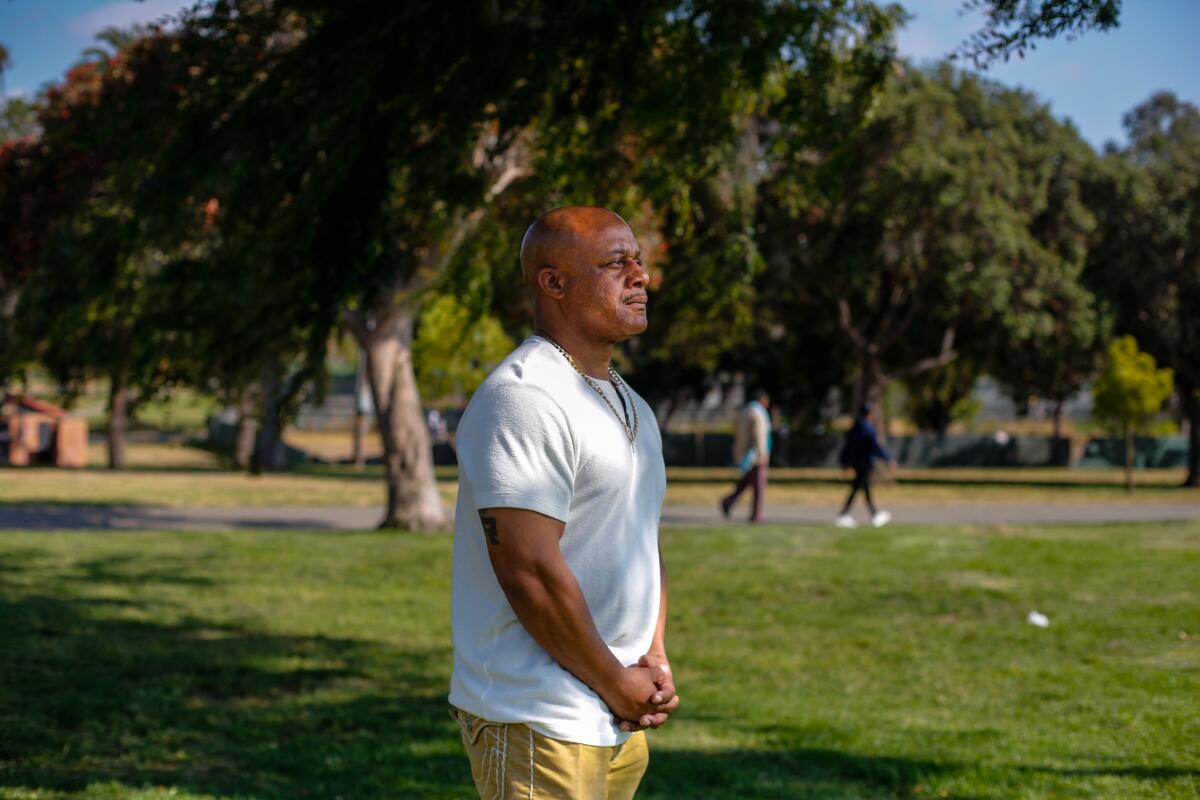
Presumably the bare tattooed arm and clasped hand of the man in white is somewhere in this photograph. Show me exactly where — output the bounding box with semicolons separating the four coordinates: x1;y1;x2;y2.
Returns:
479;509;679;727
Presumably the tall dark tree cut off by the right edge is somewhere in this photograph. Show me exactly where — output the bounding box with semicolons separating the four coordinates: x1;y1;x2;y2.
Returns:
1085;92;1200;487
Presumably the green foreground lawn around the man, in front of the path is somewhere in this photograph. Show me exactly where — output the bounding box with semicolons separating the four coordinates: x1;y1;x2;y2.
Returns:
0;523;1200;800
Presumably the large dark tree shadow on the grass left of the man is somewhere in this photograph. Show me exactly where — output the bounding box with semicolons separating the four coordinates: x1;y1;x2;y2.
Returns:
0;551;470;799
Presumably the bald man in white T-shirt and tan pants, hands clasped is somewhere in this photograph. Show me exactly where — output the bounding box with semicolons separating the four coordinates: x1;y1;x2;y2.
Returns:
450;206;679;800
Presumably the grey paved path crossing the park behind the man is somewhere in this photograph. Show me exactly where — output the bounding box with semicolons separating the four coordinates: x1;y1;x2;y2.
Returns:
0;501;1200;530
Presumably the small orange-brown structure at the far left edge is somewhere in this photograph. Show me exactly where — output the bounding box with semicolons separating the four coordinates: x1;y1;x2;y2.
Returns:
0;395;88;468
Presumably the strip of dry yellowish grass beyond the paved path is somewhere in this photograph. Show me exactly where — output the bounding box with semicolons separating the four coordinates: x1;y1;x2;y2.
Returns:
7;444;1200;510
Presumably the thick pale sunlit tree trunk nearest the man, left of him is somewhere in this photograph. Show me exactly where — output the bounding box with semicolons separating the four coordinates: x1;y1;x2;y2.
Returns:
356;308;451;530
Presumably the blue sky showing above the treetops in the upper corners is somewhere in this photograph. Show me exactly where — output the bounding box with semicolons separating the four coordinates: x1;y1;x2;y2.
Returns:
0;0;1200;146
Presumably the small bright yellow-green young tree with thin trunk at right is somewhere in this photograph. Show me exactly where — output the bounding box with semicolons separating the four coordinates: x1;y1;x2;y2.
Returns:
1092;336;1175;492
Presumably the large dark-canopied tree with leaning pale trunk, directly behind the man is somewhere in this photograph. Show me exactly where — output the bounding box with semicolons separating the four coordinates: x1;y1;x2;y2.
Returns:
4;0;894;528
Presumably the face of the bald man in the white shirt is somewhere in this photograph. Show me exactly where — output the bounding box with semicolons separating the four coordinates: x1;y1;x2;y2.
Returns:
564;218;649;342
